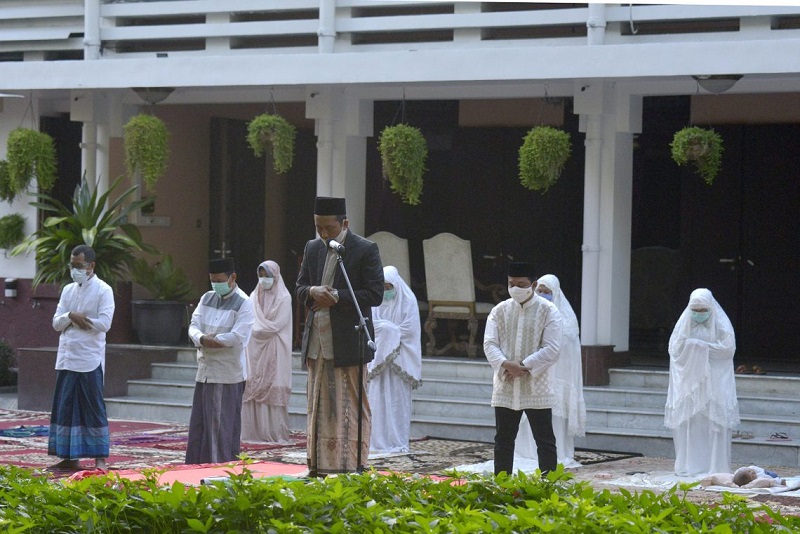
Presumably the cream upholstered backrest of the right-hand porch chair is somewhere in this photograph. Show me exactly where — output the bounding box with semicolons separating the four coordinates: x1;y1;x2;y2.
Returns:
422;232;475;302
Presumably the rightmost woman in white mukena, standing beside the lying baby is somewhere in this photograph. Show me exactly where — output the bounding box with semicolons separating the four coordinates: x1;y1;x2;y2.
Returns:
664;289;739;476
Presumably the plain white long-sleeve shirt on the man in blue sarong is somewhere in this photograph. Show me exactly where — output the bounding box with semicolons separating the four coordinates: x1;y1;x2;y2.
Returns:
53;275;114;373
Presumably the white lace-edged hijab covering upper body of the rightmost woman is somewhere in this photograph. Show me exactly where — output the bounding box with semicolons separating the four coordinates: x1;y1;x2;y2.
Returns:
664;288;739;428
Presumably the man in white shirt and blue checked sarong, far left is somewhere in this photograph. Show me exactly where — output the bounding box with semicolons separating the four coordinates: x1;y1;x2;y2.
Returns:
47;245;114;470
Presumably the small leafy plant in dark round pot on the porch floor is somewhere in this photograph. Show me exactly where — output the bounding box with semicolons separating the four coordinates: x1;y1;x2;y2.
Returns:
131;254;196;346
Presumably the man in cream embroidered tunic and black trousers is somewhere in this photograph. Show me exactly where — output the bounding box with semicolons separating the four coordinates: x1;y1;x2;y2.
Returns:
483;262;562;474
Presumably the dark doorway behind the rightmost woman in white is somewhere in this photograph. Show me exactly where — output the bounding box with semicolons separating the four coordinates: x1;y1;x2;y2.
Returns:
630;97;800;370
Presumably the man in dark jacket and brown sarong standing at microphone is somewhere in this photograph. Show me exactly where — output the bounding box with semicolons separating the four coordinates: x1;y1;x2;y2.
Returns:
296;197;383;476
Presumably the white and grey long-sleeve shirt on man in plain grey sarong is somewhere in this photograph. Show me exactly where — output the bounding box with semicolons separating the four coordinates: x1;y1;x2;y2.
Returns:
189;286;255;384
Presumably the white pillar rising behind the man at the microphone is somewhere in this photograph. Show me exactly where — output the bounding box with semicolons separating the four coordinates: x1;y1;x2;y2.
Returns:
306;87;372;233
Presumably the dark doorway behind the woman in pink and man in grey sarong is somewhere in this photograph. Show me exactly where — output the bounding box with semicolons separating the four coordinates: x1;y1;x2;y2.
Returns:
208;118;265;294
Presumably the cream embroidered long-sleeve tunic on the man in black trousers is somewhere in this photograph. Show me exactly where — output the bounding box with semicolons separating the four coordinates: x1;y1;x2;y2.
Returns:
483;295;562;410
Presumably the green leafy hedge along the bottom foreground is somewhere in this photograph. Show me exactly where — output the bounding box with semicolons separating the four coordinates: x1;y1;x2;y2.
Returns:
0;467;800;534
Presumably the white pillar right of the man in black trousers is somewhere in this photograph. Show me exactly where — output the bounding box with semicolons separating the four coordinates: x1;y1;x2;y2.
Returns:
575;81;642;351
